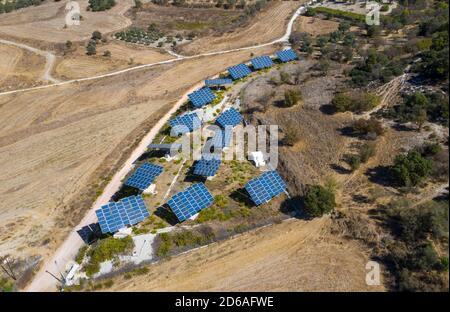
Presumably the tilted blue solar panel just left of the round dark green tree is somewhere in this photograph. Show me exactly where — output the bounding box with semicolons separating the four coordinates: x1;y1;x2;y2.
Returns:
245;170;286;206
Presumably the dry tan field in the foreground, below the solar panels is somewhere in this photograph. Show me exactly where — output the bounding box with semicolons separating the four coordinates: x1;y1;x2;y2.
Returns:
107;218;384;291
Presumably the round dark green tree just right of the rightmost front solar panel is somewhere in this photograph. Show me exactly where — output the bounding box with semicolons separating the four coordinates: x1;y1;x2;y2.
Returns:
303;185;336;217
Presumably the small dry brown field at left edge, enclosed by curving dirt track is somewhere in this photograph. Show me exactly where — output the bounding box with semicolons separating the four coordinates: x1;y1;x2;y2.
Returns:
0;43;45;91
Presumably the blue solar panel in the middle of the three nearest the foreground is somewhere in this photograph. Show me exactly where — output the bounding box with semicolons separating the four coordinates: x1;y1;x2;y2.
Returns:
167;183;214;222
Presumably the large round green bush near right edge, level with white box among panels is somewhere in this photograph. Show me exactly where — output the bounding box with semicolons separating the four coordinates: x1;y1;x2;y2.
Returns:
391;150;433;187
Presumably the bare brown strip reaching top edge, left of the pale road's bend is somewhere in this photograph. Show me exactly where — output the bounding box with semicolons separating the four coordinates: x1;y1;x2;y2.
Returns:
180;1;302;55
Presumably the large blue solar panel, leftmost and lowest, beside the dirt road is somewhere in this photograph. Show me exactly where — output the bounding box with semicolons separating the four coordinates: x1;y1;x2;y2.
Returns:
95;196;150;234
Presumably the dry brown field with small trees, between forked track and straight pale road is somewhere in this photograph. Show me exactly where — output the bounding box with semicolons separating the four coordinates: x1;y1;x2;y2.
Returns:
54;42;173;79
